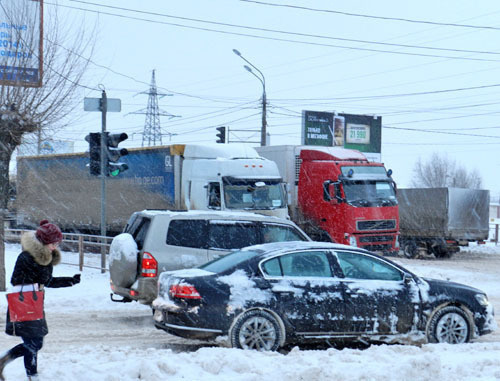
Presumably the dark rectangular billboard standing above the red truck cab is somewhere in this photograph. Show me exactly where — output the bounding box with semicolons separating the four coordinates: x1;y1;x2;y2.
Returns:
302;110;382;161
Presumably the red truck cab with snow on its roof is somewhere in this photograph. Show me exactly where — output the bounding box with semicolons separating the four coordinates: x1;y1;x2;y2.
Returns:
297;147;399;253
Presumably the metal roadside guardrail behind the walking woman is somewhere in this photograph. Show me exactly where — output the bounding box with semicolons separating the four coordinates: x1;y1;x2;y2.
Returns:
5;229;113;273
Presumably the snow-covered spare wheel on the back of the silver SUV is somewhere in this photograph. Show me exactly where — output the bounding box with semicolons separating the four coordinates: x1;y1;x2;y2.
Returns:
109;233;138;288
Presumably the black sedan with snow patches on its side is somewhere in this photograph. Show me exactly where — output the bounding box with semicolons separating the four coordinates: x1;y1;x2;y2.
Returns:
153;242;496;350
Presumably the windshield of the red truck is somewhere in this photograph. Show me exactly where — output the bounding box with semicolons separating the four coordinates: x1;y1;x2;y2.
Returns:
343;180;397;206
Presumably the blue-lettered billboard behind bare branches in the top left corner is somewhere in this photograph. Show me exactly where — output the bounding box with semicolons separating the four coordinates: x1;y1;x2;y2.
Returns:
0;0;43;87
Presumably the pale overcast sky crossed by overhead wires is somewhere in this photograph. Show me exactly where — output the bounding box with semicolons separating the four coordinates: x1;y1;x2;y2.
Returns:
30;0;500;196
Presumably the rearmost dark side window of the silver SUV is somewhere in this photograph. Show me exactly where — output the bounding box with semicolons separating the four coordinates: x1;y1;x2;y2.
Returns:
167;220;207;249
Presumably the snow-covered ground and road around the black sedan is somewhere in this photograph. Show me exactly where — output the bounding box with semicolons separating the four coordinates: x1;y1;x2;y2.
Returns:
0;244;500;381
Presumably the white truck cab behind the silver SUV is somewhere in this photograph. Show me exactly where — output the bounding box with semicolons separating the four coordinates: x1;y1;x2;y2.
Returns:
175;144;288;218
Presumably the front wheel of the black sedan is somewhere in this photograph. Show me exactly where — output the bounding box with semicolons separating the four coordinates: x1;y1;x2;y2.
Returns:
427;306;472;344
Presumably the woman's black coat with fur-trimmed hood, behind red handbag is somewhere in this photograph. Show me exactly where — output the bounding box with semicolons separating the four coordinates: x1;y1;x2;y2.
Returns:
5;232;74;337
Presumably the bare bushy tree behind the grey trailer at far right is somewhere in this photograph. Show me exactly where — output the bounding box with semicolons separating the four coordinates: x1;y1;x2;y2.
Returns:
411;153;483;189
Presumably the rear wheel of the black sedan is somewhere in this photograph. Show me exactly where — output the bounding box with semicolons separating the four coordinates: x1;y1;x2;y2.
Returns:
230;310;281;351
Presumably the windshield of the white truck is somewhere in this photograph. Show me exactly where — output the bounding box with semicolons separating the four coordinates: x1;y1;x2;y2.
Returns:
223;177;285;209
